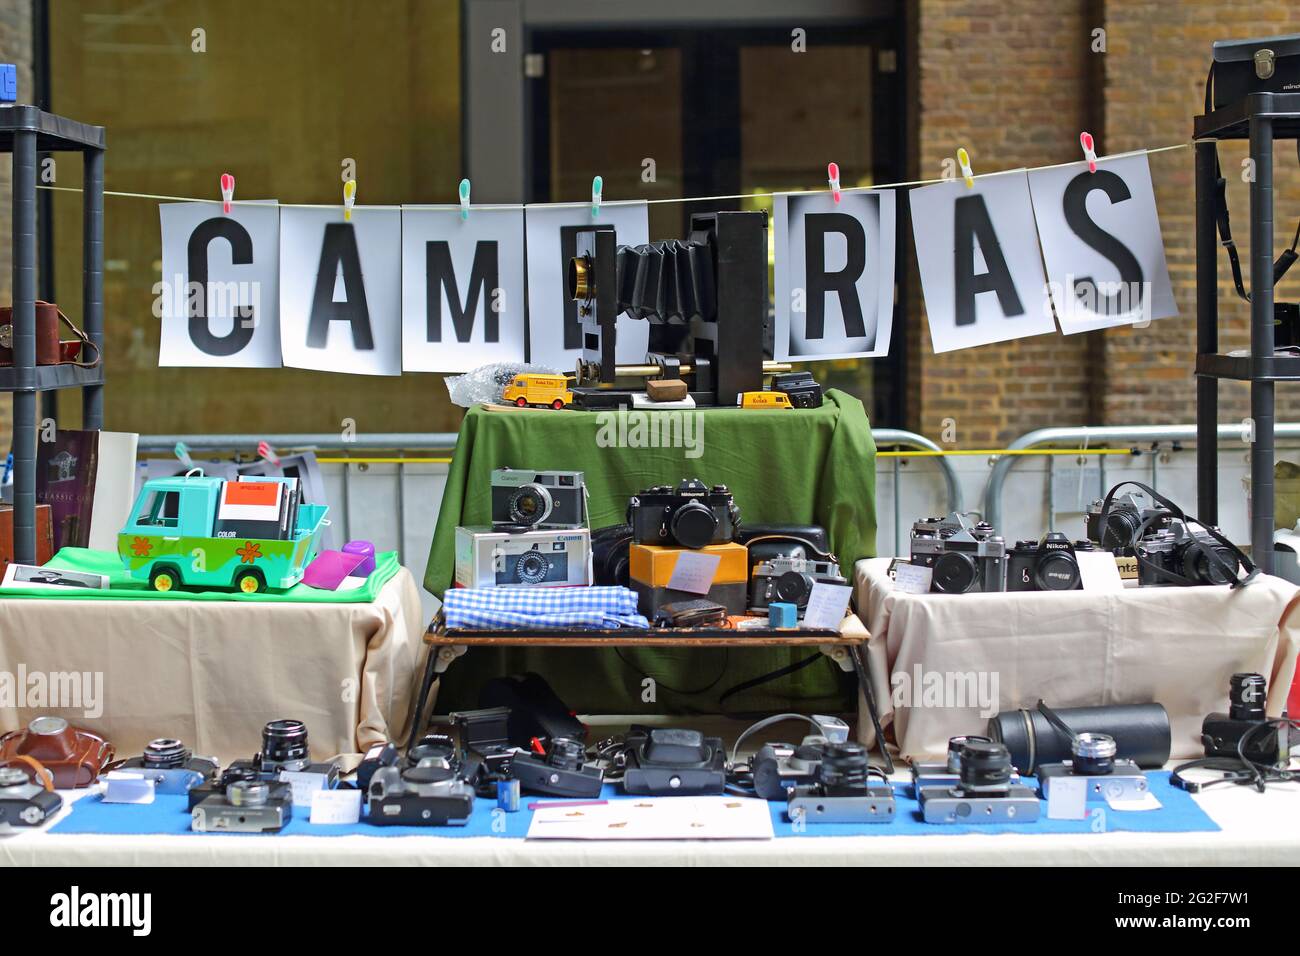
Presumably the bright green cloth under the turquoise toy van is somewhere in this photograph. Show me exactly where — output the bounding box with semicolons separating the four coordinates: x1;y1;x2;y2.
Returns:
0;548;402;604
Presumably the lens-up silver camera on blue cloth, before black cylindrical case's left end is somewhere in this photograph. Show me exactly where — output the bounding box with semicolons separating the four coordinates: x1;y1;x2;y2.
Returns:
918;740;1039;823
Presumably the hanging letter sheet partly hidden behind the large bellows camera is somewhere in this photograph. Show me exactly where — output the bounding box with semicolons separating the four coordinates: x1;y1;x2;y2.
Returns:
525;203;650;369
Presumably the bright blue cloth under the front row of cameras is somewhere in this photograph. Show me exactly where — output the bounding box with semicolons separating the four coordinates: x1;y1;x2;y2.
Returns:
43;775;1219;839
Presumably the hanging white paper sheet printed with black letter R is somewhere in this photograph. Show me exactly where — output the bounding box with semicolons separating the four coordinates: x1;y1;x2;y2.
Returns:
772;191;894;362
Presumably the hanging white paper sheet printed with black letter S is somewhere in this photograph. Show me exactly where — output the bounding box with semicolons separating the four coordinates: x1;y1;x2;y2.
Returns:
1030;153;1178;334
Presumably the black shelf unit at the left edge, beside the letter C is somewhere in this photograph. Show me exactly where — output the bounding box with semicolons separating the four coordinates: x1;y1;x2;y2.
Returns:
0;105;104;564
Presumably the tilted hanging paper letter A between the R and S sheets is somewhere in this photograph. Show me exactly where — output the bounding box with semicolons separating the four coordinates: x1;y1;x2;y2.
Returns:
910;169;1056;352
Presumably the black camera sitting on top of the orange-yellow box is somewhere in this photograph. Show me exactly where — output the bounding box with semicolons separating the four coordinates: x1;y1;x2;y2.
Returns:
628;479;740;549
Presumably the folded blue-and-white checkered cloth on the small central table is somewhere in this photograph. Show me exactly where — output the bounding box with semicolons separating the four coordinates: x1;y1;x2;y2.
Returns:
442;588;650;631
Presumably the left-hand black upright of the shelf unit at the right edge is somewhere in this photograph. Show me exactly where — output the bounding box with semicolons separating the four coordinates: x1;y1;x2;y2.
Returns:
1196;142;1218;524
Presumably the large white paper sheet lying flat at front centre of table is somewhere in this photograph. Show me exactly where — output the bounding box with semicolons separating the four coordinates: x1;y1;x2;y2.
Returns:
528;796;774;840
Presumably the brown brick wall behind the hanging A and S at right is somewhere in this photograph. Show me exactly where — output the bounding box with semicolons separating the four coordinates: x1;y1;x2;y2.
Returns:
906;0;1300;447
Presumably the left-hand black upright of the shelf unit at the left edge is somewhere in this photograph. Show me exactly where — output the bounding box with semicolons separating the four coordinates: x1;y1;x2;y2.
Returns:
12;130;36;564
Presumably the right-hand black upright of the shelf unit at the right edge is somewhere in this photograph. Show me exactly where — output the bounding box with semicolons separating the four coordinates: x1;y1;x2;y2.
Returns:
1251;116;1274;574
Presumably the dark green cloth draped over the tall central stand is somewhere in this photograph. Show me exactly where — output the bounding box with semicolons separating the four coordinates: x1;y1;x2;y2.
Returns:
425;389;876;714
